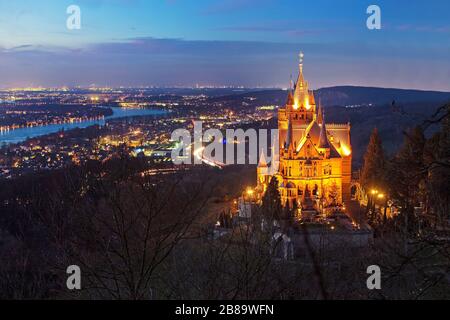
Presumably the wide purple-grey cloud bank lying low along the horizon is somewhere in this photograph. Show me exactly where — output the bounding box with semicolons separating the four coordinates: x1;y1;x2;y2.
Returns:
0;37;450;90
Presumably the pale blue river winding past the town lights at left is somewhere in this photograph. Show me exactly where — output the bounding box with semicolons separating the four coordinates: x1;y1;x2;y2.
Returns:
0;107;167;145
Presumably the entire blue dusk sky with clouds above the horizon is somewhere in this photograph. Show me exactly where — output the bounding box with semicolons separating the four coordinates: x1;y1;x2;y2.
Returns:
0;0;450;91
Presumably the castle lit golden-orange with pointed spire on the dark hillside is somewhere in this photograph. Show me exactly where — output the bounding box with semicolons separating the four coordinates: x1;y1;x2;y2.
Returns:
258;53;352;209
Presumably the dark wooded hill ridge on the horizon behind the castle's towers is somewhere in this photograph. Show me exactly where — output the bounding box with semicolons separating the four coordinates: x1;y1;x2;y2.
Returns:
211;86;450;169
